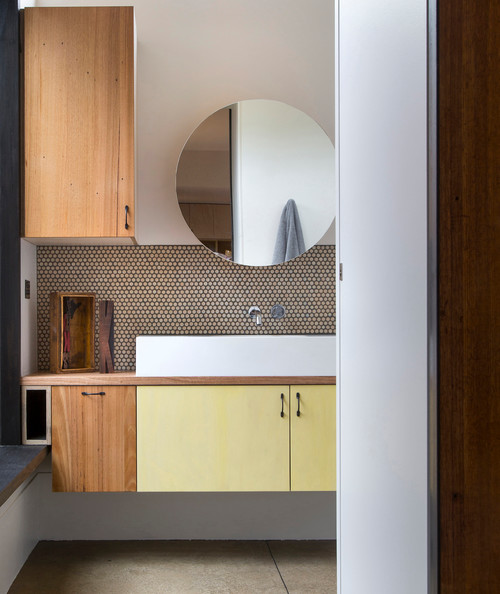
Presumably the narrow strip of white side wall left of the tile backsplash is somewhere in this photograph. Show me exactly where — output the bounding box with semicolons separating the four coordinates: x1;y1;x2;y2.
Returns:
20;239;37;375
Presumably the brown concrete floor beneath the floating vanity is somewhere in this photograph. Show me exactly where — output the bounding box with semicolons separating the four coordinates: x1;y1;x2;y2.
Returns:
9;541;337;594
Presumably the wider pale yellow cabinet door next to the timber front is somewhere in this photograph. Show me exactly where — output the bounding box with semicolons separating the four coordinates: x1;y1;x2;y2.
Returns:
137;386;290;491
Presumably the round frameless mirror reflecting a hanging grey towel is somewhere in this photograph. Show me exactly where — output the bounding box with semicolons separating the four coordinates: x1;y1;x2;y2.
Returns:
176;99;335;266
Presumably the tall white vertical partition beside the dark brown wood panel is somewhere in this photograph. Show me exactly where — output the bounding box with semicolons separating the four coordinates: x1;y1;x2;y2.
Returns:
338;0;428;594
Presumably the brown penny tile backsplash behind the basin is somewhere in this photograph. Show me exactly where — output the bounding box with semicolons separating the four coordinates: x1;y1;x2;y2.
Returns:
37;245;335;371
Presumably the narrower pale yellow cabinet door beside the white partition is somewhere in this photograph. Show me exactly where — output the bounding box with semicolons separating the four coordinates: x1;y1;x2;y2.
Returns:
290;386;336;491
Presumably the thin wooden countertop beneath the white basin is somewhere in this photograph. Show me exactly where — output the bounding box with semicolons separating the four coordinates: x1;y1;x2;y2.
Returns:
21;371;337;386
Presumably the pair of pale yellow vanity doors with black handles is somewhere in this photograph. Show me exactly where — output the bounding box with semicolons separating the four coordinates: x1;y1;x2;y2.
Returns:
137;385;336;491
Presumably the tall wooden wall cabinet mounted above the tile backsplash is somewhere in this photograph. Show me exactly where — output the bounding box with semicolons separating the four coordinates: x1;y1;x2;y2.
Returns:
22;7;135;238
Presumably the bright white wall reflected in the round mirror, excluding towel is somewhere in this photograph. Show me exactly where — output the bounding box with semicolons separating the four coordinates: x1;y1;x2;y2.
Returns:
233;100;336;266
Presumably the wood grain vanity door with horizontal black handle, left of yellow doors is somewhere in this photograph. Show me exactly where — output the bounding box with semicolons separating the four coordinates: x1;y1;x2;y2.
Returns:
52;386;136;491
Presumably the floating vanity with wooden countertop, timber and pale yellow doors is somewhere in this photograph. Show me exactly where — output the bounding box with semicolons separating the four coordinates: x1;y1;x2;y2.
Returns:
21;372;336;492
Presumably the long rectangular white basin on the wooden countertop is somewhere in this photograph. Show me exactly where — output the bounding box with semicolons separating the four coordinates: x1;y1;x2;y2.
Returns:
136;334;336;377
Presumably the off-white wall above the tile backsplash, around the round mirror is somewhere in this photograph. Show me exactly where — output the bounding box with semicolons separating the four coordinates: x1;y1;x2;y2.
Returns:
26;0;334;245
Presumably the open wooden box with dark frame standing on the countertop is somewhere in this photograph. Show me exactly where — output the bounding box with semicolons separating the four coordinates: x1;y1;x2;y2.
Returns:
50;292;95;373
